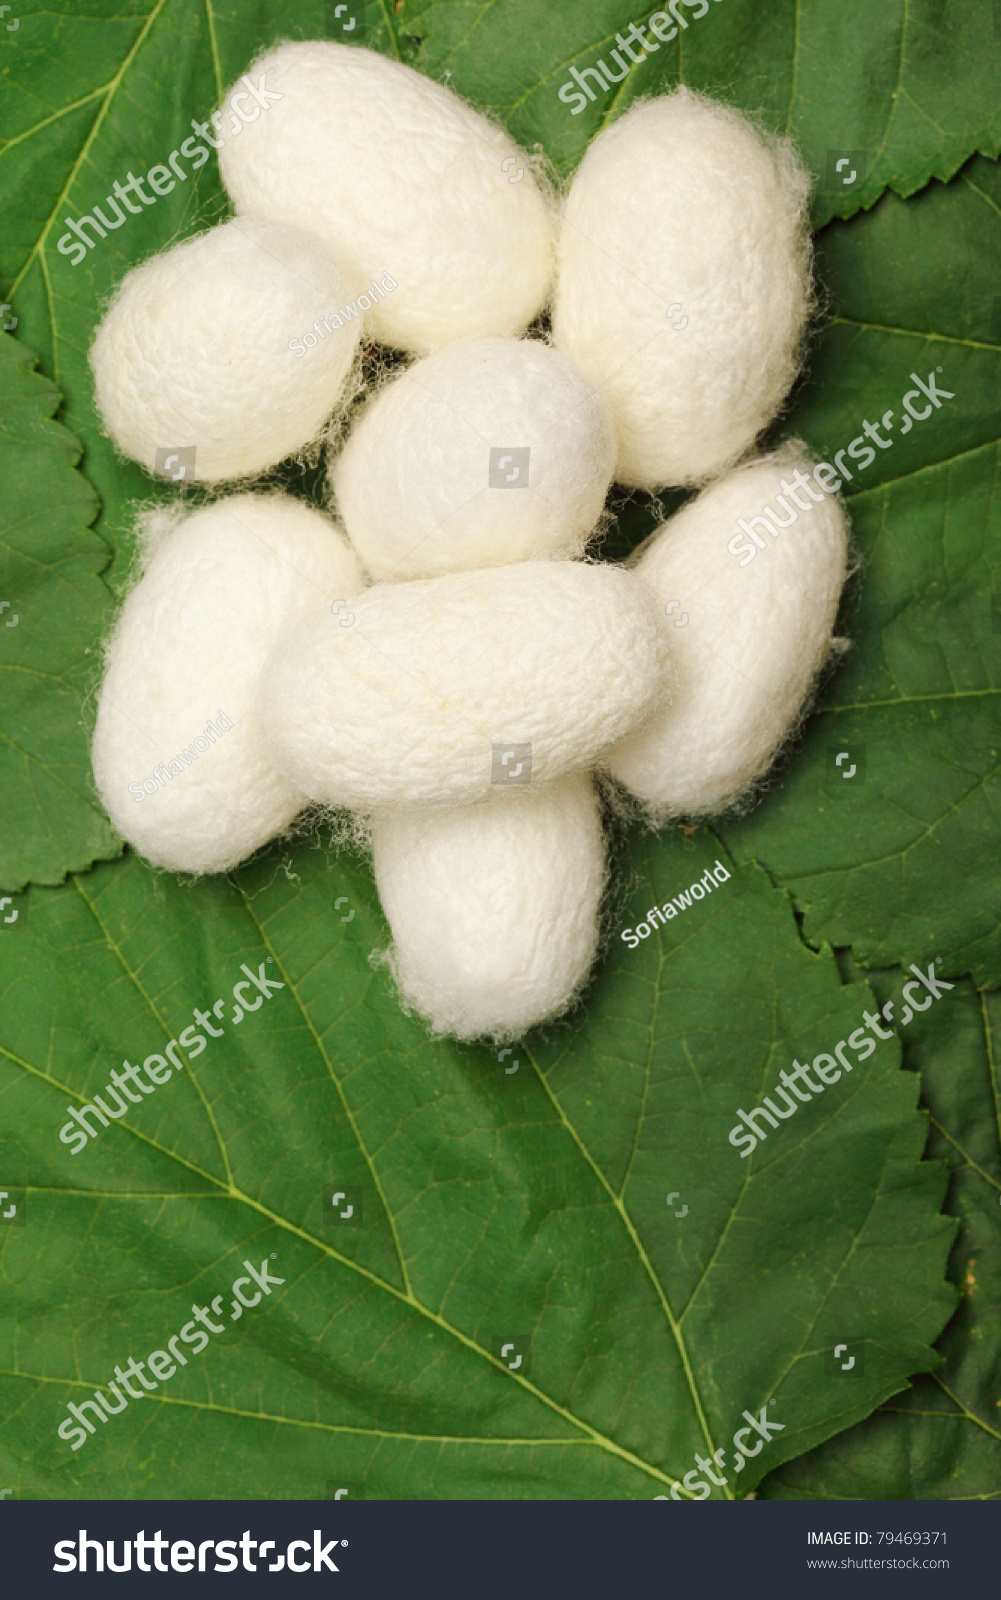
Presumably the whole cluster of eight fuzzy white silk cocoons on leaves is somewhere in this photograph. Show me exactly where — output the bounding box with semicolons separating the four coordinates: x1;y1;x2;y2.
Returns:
91;42;847;1043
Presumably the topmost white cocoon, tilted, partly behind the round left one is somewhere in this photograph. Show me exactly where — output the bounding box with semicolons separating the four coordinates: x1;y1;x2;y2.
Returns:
219;42;553;354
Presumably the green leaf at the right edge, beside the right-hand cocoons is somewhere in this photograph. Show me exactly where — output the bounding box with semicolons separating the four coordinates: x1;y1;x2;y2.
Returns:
721;158;1001;984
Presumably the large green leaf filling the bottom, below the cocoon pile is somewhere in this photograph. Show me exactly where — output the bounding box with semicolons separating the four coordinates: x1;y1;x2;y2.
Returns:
0;835;955;1499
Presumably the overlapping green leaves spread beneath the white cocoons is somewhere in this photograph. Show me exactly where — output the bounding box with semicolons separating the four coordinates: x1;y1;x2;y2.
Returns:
0;0;1001;1499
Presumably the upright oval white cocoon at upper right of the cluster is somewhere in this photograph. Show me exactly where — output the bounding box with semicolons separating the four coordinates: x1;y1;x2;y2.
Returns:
553;88;811;490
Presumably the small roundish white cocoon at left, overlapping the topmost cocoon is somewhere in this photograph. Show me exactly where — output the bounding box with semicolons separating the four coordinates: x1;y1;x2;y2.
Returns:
91;218;358;482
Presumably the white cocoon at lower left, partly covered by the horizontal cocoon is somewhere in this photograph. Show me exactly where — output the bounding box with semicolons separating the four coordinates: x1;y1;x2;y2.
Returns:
93;494;361;872
